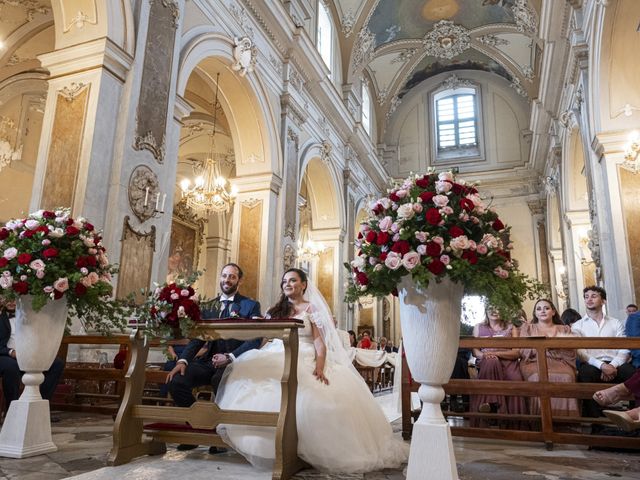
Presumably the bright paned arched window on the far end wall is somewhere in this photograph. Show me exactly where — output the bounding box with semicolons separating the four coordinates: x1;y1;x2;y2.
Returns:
434;87;480;159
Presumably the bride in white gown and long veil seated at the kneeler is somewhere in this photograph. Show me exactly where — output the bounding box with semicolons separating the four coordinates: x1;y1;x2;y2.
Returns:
216;268;409;473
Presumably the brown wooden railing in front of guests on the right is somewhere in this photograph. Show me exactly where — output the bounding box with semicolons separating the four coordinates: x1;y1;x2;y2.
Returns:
402;337;640;449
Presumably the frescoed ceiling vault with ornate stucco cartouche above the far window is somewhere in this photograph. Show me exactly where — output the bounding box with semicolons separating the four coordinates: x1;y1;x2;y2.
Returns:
336;0;542;118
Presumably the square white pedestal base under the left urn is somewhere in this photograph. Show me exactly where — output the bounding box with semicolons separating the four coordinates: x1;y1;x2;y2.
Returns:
0;398;58;458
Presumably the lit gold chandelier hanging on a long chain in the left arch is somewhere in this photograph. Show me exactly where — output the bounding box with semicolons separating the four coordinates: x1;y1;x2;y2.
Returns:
180;73;238;214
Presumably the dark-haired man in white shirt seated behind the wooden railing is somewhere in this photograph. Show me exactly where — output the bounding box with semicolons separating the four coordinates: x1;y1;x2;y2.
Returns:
571;286;635;417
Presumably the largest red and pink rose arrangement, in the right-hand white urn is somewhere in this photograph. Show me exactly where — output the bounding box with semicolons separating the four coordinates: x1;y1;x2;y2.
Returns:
345;172;546;318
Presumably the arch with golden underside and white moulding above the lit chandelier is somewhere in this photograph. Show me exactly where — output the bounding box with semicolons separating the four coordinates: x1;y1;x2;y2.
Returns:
177;31;282;177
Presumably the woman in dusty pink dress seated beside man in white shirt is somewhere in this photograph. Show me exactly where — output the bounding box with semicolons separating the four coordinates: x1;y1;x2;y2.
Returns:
520;299;579;416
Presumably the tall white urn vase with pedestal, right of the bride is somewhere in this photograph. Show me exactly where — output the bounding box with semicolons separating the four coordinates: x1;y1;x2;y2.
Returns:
398;275;463;480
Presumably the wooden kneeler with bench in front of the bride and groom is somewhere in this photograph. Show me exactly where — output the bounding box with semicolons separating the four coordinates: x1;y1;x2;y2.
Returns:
107;319;308;480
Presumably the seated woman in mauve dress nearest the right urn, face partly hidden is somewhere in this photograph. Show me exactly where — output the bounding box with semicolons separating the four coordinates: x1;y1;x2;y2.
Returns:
471;307;527;426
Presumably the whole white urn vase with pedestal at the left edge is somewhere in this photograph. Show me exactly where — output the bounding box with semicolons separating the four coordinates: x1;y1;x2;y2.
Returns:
0;295;67;458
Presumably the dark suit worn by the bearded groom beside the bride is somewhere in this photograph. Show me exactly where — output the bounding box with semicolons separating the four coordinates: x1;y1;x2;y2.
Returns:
169;293;262;407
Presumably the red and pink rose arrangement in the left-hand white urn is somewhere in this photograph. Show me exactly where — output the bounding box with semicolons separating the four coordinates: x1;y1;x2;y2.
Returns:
0;208;126;332
